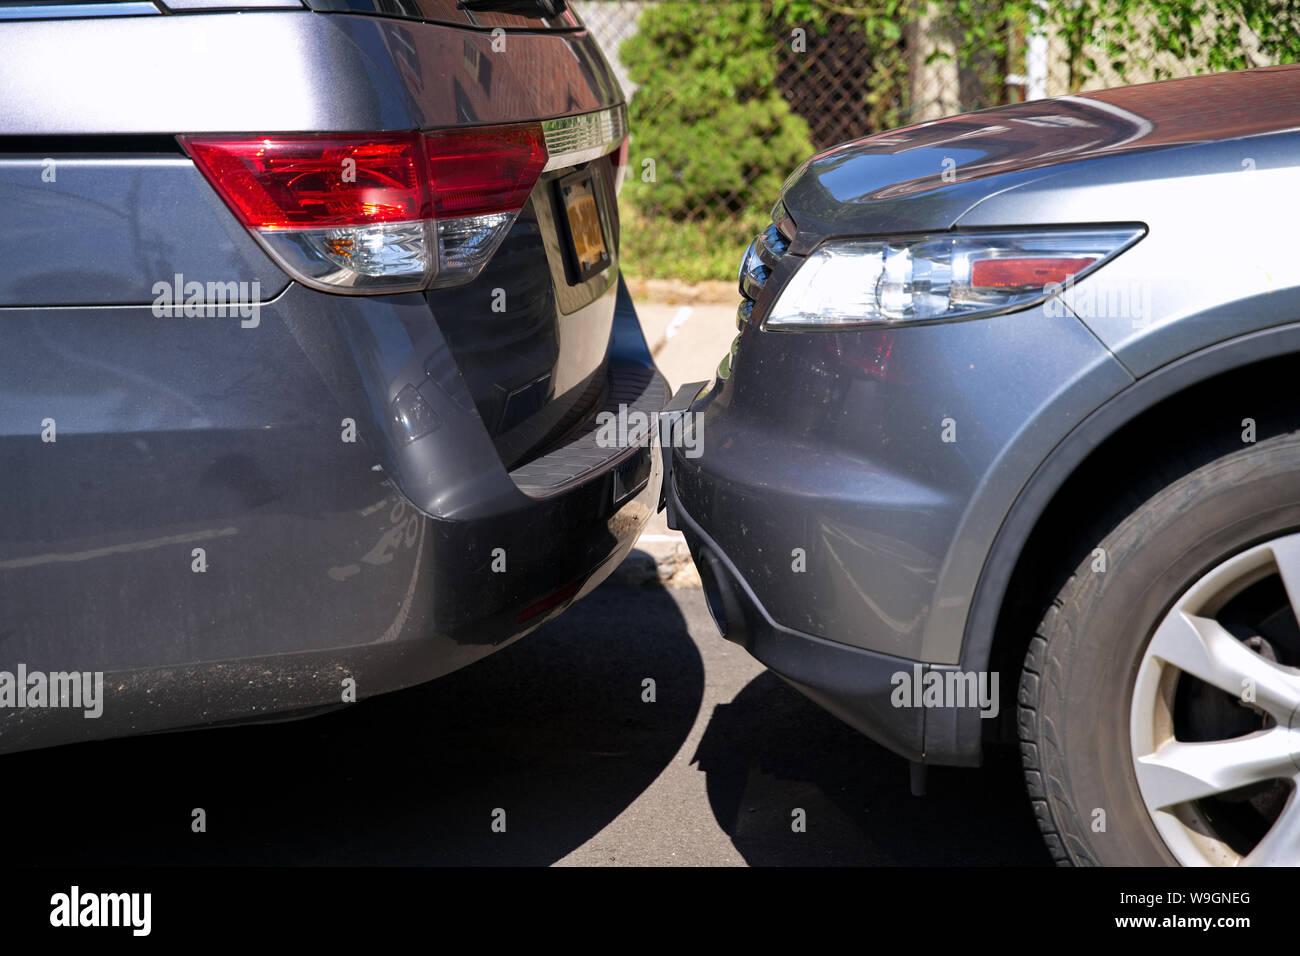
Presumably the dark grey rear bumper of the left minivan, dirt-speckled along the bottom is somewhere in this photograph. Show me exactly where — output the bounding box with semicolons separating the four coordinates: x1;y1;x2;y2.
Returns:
0;270;667;750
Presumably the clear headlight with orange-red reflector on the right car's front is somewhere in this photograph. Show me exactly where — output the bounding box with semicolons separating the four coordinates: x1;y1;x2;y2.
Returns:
764;225;1147;332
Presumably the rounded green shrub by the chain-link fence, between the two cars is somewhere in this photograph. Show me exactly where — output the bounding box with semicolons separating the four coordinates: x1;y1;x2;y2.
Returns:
620;0;813;278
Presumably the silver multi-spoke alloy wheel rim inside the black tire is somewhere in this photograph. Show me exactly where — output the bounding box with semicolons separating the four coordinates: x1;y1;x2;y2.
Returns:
1128;535;1300;866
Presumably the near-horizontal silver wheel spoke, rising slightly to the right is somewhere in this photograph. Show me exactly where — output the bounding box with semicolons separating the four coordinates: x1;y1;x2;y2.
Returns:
1136;727;1296;810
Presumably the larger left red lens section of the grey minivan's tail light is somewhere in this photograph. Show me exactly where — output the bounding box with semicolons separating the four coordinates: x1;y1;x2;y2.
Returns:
179;133;429;230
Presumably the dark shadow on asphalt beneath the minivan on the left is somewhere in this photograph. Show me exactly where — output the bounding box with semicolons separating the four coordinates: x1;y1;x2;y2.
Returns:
0;574;703;865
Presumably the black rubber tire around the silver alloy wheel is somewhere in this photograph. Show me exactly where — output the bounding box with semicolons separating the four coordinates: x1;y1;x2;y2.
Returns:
1018;434;1300;865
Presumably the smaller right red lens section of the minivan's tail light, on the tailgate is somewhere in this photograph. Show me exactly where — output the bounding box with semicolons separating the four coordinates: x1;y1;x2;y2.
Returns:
424;124;546;219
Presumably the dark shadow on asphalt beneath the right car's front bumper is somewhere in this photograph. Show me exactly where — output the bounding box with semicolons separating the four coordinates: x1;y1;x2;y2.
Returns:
694;671;1050;866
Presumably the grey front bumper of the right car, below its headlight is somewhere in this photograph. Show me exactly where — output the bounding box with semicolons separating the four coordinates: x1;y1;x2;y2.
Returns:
668;299;1131;763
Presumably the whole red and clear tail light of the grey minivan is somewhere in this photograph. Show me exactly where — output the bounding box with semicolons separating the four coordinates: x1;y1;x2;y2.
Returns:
179;124;547;294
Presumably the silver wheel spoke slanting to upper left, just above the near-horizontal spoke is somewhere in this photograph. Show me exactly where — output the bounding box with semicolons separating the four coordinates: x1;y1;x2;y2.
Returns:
1149;610;1300;724
